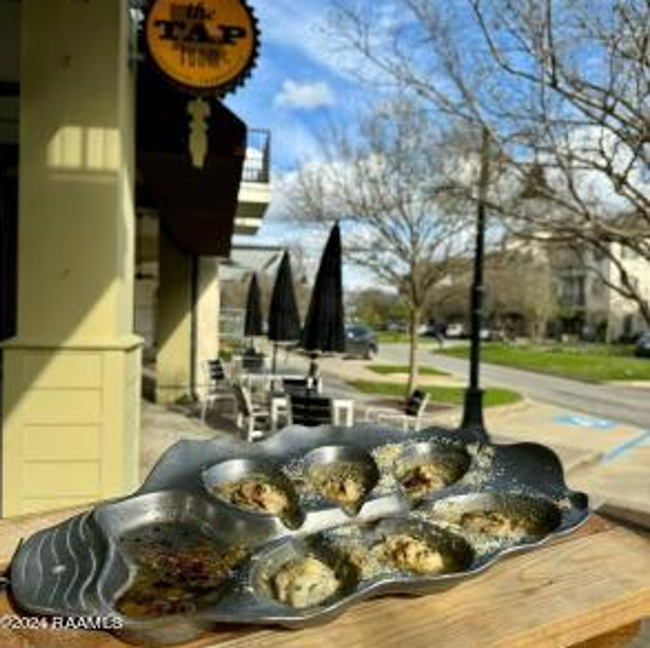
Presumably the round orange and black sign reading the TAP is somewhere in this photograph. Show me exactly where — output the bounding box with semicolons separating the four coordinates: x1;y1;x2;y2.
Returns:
145;0;259;94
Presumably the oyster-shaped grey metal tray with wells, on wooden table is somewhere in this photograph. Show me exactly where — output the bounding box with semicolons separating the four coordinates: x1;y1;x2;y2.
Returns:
10;425;589;645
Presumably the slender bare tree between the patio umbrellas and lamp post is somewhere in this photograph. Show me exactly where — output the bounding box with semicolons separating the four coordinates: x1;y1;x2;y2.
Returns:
290;98;465;393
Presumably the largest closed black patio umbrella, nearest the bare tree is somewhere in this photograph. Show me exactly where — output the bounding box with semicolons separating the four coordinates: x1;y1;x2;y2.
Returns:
301;223;345;377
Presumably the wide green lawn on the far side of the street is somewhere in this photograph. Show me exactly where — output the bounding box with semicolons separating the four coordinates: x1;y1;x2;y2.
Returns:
437;344;650;382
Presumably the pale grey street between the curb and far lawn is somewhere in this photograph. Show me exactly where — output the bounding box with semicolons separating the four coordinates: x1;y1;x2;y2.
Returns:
378;344;650;428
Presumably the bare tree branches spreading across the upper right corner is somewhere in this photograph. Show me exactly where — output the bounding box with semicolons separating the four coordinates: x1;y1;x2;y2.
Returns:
331;0;650;324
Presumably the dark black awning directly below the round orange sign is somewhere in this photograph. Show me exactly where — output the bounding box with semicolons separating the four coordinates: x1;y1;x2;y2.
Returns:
136;65;246;256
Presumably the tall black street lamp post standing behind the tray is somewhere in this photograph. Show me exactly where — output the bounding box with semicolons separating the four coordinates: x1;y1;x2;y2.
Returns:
462;127;490;430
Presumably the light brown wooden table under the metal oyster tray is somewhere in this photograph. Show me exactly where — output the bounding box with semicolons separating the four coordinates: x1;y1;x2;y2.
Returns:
0;511;650;648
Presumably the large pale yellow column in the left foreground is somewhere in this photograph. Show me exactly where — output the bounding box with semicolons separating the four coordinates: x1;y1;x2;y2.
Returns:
2;0;141;516
